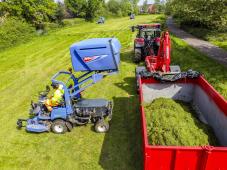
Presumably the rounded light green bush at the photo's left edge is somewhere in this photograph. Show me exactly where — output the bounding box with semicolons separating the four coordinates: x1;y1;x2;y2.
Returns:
0;18;35;51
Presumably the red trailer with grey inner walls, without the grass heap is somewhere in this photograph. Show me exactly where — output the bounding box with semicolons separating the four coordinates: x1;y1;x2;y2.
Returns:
138;76;227;170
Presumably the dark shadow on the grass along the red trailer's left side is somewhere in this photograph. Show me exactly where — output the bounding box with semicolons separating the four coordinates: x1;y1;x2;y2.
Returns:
99;95;142;170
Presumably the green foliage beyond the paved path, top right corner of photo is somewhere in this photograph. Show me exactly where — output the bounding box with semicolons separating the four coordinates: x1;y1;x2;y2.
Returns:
167;0;227;29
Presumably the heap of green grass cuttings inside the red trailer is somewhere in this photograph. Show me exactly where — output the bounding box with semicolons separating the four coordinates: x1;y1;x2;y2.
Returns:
144;98;218;146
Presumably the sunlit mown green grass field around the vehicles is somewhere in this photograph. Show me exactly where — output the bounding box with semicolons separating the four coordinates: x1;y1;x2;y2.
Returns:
0;15;227;170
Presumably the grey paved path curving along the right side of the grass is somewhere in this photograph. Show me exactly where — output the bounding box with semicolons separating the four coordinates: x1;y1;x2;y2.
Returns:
167;17;227;67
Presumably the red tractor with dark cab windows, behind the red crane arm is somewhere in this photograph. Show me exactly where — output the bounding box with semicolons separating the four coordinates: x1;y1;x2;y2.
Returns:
132;24;161;63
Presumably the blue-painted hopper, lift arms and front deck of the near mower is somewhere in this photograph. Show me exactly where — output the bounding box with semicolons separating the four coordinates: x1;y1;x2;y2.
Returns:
18;38;121;133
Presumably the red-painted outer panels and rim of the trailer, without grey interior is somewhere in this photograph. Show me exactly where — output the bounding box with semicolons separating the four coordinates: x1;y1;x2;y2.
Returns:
139;76;227;170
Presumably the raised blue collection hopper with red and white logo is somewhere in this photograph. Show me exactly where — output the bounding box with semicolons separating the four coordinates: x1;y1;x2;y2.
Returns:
70;38;121;71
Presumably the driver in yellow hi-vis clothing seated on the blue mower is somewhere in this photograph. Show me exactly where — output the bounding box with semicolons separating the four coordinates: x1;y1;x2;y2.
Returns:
45;83;64;112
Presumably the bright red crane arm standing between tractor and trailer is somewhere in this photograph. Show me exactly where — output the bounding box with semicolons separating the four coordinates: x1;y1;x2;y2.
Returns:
145;32;171;72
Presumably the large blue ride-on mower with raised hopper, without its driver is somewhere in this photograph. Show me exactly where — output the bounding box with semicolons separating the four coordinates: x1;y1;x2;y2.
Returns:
17;38;121;134
